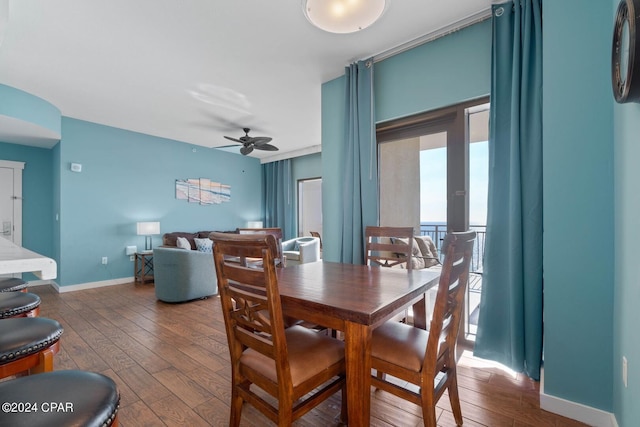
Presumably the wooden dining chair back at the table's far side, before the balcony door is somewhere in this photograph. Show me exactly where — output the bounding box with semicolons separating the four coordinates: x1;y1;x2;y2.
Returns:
364;226;415;270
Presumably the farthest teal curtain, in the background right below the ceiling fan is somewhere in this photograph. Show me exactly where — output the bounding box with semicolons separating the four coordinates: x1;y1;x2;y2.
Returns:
262;159;298;240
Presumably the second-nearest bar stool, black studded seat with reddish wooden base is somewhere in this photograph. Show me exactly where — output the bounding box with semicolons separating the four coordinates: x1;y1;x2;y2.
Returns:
0;317;64;378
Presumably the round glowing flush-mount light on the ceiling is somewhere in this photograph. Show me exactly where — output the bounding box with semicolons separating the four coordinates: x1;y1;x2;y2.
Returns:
302;0;387;34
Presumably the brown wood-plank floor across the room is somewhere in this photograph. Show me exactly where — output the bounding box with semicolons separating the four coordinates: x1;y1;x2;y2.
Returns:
30;283;584;427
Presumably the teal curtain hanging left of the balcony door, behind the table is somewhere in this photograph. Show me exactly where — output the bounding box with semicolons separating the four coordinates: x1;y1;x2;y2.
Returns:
340;59;378;264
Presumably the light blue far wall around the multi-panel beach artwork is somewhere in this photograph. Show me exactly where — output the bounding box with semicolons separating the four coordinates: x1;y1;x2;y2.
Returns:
54;118;262;286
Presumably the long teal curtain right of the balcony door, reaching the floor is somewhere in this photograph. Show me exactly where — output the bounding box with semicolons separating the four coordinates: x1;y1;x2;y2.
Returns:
474;0;543;380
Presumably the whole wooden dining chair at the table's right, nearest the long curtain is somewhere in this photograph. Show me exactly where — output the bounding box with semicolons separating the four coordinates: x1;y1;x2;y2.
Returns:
371;231;476;427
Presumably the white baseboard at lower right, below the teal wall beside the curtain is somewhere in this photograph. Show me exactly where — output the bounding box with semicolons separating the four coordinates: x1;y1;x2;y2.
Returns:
540;370;618;427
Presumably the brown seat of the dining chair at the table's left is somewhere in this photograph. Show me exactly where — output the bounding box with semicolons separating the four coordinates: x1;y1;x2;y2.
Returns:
240;326;344;387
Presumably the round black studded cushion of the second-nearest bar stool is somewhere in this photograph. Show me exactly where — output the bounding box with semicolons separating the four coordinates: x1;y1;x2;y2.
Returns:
0;317;64;364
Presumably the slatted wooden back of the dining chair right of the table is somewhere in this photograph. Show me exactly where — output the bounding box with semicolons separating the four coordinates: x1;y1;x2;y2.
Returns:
423;231;476;379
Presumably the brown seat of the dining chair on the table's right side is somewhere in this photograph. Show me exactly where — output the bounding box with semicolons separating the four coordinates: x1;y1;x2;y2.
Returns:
371;321;429;372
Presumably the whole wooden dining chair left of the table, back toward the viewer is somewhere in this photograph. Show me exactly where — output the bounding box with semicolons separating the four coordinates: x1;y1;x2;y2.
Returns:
210;233;347;426
